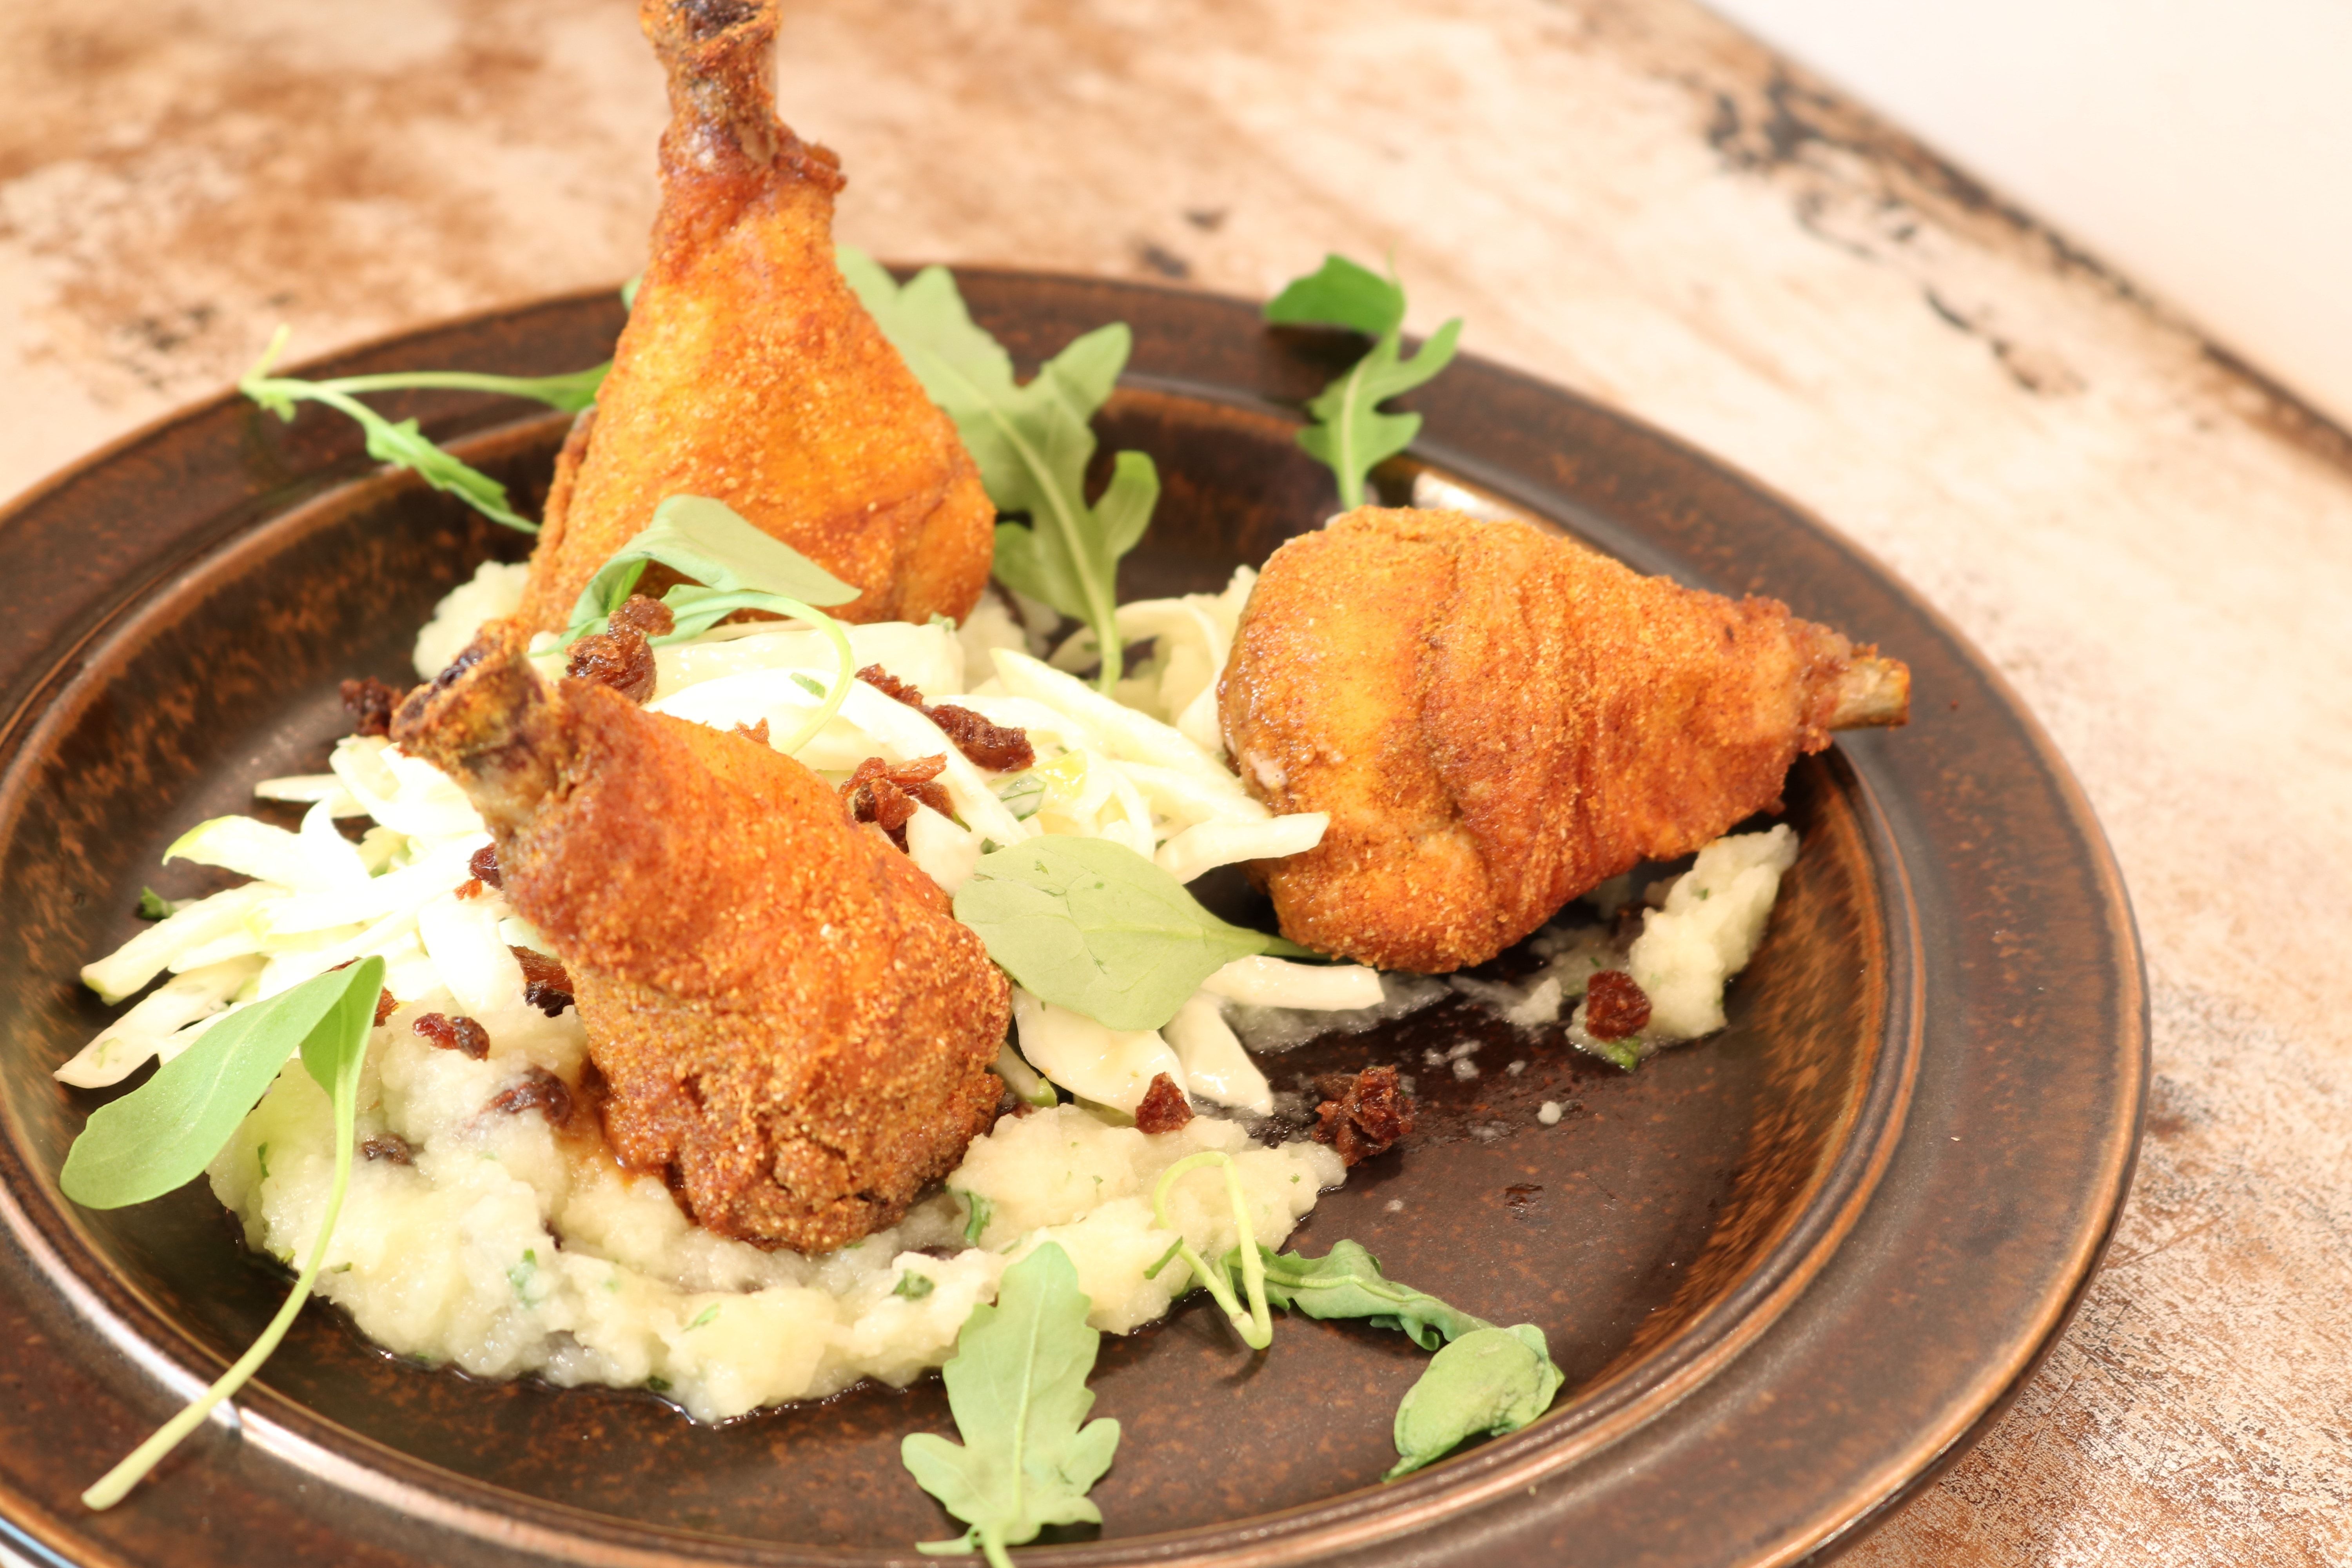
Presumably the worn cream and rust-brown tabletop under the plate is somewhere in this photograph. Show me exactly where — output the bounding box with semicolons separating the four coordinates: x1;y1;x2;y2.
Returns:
0;0;2352;1568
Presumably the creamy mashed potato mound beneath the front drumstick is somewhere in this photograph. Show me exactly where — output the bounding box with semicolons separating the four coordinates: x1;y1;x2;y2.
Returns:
212;995;1341;1420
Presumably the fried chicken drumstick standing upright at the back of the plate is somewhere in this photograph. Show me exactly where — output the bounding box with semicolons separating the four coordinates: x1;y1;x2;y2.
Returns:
522;0;995;630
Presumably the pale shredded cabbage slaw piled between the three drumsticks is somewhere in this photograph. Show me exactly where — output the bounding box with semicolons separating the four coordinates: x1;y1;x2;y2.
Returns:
56;562;1381;1114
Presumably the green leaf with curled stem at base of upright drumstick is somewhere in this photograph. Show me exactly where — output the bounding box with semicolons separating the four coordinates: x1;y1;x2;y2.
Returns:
564;496;858;757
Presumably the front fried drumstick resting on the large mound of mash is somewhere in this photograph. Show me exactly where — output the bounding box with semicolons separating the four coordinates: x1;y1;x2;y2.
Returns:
393;623;1011;1253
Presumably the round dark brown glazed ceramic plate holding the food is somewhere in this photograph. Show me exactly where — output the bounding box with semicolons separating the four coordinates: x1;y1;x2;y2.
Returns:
0;270;2147;1568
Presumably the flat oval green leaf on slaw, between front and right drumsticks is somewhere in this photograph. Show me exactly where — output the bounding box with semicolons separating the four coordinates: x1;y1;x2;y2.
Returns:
955;835;1298;1030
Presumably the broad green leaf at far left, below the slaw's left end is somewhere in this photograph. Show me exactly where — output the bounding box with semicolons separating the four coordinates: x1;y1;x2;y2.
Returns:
56;959;383;1208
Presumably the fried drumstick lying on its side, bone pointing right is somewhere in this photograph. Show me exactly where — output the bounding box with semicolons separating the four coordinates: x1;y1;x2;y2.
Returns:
1218;508;1910;973
